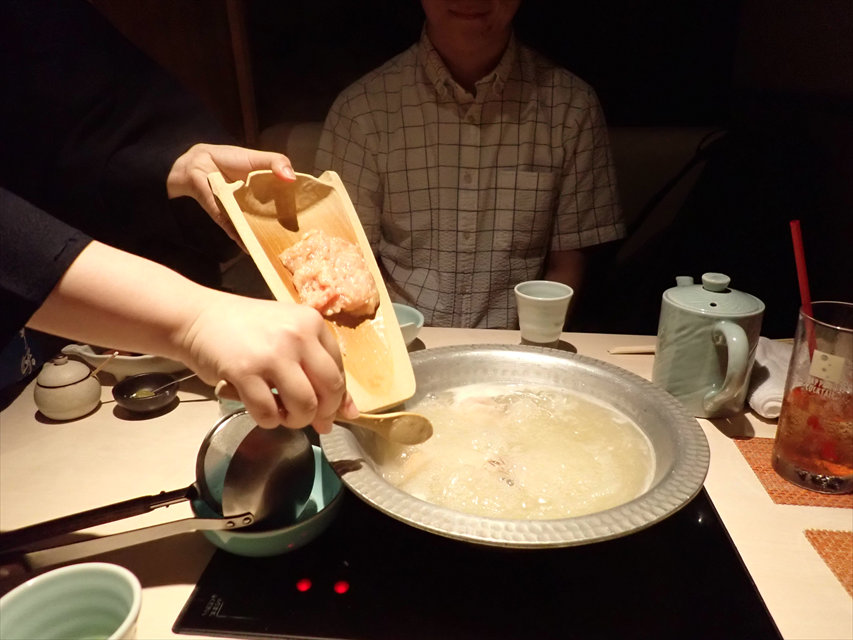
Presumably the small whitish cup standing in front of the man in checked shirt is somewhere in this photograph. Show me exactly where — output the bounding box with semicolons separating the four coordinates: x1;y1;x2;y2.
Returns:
515;280;574;345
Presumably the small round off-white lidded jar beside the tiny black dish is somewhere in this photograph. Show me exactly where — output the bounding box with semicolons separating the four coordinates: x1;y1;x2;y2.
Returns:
33;356;101;420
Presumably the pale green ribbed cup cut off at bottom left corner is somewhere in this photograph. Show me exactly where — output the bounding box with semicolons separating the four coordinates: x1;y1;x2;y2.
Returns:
0;562;142;640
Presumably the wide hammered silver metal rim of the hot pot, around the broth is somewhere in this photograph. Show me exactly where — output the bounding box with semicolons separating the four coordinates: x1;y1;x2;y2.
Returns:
320;345;710;548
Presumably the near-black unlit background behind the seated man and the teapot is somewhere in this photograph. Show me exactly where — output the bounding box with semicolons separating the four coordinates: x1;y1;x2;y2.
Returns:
93;0;853;337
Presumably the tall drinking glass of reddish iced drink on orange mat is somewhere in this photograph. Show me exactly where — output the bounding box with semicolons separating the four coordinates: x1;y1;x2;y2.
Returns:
773;302;853;493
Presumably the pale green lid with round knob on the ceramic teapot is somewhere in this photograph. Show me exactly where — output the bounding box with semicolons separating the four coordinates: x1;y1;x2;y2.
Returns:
663;273;764;317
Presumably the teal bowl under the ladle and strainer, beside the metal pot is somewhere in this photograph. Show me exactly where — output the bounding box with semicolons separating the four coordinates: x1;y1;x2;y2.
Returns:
192;446;344;558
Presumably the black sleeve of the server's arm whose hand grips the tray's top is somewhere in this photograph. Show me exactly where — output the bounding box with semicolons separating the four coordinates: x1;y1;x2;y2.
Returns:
0;0;234;270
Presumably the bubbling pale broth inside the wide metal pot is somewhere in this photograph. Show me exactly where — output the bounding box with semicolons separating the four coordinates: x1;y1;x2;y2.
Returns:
372;384;654;520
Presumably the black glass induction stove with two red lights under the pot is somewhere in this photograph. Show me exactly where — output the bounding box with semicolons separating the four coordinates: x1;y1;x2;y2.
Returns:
173;489;781;640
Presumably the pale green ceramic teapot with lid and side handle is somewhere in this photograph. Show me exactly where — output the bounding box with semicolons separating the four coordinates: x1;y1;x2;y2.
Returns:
652;273;764;418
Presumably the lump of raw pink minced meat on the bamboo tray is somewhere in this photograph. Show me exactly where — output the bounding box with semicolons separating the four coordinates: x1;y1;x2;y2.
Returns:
279;229;379;316
